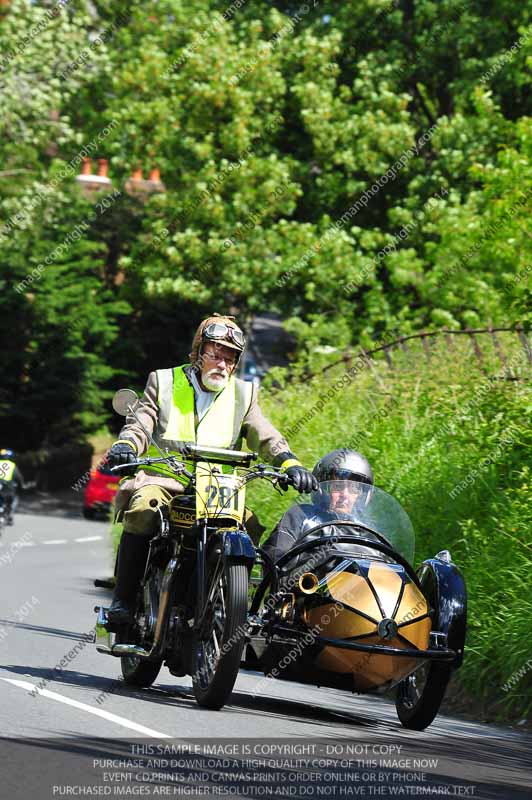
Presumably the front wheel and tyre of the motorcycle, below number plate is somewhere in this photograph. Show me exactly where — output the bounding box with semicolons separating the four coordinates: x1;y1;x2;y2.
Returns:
192;562;248;709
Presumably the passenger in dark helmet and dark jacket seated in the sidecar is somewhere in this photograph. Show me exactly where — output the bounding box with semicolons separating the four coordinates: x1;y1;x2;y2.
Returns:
262;449;374;563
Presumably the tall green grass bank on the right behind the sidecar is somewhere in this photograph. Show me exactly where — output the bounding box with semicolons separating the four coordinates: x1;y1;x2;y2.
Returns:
248;337;532;719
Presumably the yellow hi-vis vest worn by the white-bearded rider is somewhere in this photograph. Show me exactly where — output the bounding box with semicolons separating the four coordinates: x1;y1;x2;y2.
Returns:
142;364;253;483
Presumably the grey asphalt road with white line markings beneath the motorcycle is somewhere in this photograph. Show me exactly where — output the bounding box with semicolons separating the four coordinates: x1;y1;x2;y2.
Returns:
0;514;532;800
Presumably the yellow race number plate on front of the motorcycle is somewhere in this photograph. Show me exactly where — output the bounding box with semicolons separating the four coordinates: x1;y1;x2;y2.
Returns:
196;462;246;522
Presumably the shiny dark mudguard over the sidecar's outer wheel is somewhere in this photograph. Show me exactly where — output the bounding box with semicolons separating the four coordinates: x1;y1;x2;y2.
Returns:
417;557;467;669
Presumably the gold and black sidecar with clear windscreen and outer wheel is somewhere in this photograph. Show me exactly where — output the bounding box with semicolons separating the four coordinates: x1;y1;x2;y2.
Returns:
244;481;467;730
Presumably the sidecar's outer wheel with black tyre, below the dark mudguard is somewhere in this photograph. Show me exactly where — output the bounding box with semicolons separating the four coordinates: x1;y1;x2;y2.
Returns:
395;662;452;731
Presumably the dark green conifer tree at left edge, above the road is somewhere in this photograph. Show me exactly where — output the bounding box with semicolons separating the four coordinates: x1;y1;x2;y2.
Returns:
0;186;129;449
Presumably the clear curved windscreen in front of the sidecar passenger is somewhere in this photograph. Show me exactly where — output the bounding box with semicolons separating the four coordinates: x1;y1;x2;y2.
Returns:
297;480;415;563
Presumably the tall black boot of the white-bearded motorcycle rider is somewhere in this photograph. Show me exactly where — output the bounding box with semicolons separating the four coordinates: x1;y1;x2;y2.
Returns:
107;532;150;630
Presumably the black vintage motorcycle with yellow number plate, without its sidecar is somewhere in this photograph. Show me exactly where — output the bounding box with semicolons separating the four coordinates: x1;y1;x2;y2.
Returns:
95;389;288;709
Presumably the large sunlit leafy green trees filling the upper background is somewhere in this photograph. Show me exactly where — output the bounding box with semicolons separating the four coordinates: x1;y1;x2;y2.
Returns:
0;0;531;438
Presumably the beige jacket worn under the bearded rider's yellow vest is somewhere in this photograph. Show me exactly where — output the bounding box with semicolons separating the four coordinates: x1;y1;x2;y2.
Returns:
116;366;295;510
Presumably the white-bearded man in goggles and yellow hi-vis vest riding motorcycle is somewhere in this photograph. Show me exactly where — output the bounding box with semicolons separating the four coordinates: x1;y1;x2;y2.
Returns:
108;314;318;627
